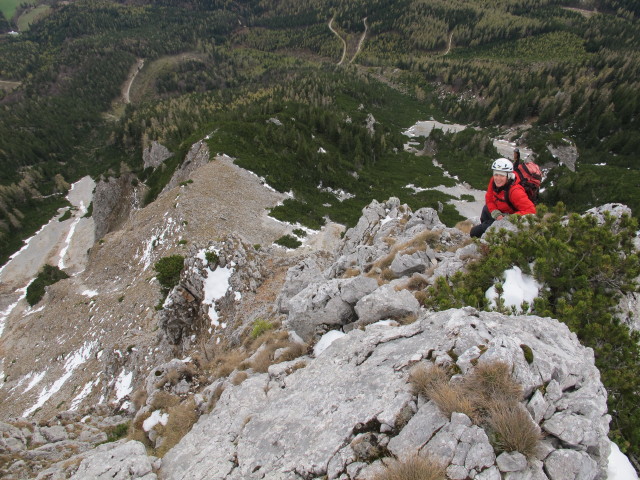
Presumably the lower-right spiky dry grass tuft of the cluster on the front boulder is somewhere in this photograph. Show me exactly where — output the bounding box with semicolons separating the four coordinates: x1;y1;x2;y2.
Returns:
489;402;542;457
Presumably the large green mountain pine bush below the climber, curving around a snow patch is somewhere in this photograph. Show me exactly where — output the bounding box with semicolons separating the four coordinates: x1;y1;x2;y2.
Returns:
424;204;640;455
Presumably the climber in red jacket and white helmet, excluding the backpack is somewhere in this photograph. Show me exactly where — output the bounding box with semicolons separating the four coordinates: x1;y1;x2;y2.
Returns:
469;158;536;237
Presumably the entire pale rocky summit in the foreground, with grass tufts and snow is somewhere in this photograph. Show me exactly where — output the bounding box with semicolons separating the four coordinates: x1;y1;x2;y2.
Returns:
0;182;632;480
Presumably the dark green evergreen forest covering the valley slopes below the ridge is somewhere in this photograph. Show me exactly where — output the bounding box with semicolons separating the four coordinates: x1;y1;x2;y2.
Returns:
0;0;640;462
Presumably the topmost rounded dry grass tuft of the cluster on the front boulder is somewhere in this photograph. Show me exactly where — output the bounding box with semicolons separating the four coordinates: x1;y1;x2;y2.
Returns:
463;362;523;410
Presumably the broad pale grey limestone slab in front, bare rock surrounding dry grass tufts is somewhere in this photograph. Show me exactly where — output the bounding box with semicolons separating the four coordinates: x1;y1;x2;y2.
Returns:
161;308;609;480
